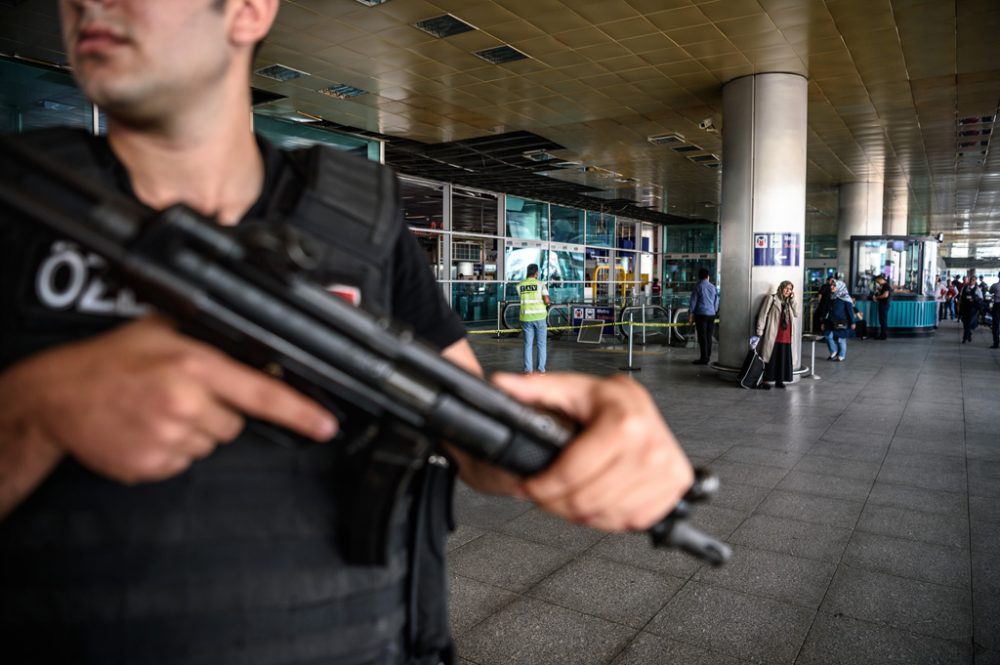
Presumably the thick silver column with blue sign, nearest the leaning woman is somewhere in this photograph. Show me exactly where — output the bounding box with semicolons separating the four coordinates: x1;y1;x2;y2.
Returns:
718;74;807;369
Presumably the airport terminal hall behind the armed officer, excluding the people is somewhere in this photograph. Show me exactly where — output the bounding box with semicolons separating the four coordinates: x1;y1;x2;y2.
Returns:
0;0;1000;665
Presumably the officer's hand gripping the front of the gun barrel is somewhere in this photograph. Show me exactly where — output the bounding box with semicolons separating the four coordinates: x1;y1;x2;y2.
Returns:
494;374;694;531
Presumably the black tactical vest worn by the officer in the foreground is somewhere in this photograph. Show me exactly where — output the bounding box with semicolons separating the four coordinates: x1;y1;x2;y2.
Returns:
0;130;453;665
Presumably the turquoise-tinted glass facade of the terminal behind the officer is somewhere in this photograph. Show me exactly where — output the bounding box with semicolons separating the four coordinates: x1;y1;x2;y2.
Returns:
0;59;717;328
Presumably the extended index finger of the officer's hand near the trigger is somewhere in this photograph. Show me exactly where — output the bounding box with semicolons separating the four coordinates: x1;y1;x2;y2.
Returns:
196;354;337;441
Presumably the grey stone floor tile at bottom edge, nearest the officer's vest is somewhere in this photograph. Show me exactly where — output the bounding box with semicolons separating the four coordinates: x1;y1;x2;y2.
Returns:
457;598;636;665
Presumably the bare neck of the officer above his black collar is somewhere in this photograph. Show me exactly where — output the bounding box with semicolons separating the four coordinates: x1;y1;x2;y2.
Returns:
108;94;264;224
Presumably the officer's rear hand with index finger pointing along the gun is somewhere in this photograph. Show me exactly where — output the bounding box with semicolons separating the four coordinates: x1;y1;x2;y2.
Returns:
19;317;336;483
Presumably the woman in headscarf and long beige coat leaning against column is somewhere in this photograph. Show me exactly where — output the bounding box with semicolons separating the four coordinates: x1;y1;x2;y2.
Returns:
756;280;799;390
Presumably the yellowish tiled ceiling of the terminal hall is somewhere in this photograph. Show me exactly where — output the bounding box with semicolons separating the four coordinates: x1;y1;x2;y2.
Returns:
0;0;1000;256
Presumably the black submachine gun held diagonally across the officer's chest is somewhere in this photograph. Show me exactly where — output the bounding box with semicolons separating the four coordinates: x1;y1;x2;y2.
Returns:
0;138;730;565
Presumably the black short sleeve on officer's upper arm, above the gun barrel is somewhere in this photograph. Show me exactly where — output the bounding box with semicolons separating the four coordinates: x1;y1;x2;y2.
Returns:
392;229;465;349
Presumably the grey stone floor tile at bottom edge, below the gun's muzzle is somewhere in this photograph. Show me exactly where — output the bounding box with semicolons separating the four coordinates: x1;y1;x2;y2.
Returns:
646;582;816;663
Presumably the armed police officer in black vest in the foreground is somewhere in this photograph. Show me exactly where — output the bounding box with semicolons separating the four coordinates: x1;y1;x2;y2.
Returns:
0;0;693;665
